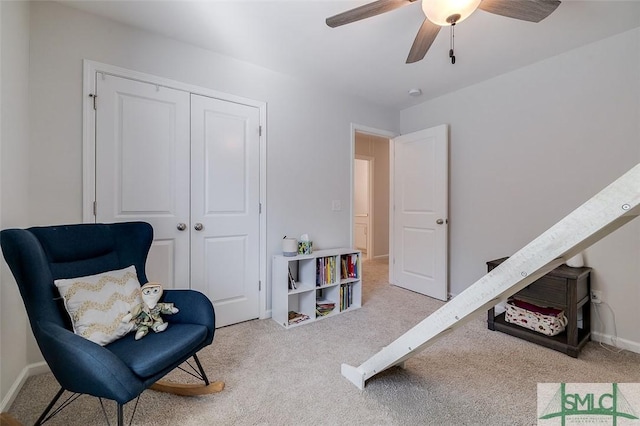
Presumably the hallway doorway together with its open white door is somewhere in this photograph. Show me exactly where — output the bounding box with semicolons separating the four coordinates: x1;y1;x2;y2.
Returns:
351;125;449;300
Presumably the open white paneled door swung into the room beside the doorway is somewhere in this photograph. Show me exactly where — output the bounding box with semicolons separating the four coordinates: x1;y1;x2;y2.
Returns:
389;125;449;300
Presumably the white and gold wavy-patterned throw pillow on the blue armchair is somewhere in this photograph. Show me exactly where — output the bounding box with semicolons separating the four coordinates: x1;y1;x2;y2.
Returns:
54;265;142;346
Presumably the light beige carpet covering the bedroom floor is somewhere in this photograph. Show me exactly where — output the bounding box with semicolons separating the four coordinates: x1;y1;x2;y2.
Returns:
9;261;640;425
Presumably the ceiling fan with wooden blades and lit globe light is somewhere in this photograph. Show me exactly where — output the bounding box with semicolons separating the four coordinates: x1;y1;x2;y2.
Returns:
326;0;560;64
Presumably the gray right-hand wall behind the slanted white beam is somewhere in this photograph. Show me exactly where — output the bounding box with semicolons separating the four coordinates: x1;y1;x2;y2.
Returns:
400;29;640;352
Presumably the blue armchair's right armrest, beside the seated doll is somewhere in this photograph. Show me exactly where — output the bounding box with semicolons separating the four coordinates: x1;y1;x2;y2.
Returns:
162;290;216;338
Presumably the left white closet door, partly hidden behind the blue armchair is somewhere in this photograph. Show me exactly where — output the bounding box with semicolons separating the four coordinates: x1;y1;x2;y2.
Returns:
95;73;190;288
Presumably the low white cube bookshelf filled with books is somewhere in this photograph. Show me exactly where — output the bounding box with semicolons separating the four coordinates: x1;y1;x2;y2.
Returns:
271;248;362;328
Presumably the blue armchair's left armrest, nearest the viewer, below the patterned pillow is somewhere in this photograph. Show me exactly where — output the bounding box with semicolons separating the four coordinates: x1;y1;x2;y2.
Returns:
36;321;144;404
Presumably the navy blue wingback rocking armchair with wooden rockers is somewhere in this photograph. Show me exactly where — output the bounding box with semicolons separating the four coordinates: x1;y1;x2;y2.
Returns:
0;222;224;425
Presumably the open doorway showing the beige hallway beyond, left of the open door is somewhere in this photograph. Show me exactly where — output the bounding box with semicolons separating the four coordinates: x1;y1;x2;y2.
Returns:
352;129;391;275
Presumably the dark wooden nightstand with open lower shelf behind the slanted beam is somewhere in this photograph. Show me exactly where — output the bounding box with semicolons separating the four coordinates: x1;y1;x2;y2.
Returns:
487;257;591;358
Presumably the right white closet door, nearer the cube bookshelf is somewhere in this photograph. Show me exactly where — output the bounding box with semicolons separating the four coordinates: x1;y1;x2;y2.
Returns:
191;95;260;326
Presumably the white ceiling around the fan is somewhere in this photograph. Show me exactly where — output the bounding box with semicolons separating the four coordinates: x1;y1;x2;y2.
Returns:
61;0;640;109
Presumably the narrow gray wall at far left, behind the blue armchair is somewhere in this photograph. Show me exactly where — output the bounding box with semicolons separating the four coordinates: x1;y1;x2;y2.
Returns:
0;1;31;411
